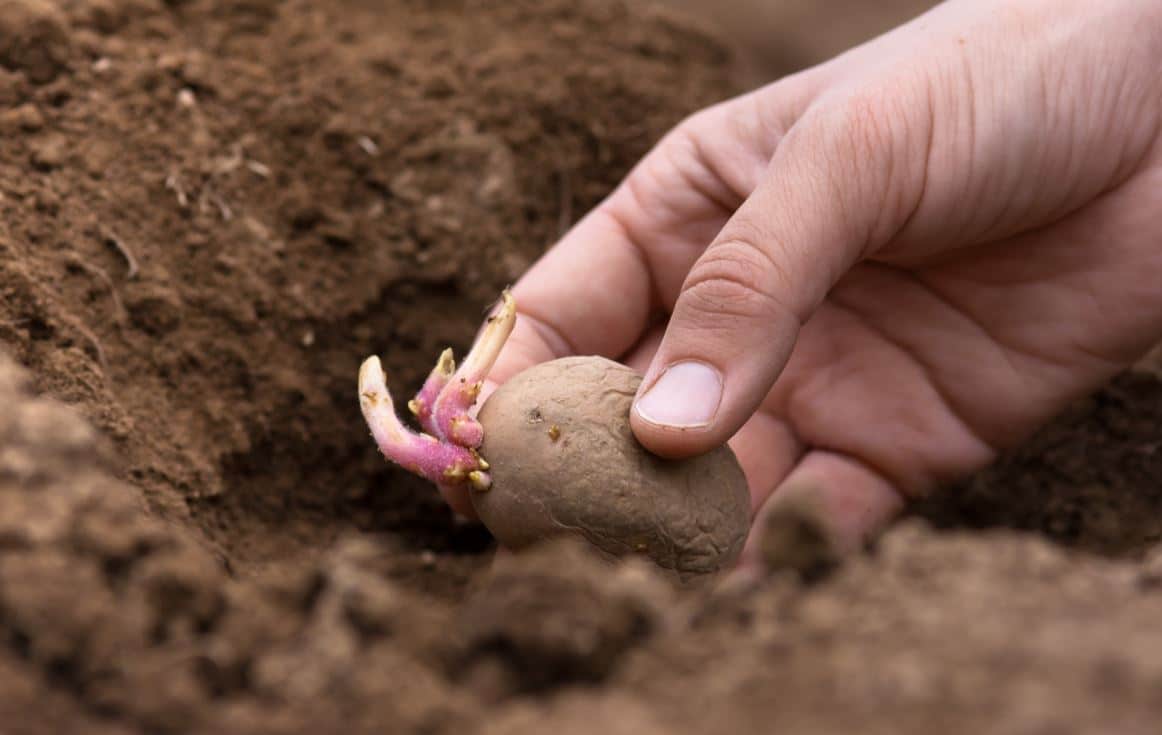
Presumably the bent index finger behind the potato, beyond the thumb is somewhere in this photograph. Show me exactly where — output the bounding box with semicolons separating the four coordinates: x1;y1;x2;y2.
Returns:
489;95;773;382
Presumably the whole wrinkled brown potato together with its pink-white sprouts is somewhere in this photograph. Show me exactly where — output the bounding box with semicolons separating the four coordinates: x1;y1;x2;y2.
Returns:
359;294;751;581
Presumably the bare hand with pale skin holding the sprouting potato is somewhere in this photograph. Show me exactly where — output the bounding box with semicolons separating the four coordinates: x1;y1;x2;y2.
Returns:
450;0;1162;559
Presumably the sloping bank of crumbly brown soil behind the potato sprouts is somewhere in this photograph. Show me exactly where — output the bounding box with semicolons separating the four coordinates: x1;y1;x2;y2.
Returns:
0;0;727;574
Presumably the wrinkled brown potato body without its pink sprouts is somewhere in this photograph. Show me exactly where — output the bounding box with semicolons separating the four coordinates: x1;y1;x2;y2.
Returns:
472;356;751;581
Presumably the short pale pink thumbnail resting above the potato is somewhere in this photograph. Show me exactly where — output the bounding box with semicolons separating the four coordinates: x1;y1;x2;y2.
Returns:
636;362;723;428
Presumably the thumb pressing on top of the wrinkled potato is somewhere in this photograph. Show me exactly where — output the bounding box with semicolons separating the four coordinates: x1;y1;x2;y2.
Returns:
630;95;928;456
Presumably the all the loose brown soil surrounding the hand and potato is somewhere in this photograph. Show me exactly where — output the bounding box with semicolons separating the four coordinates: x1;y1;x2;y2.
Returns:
0;0;1162;735
